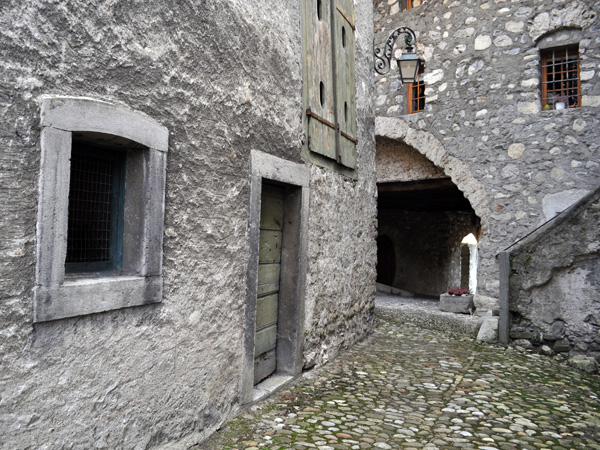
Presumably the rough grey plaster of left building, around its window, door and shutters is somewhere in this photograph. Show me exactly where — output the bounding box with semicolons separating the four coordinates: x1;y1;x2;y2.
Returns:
0;0;375;449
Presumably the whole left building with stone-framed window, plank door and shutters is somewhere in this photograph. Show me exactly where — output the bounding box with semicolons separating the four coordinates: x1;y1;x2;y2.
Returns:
0;0;376;449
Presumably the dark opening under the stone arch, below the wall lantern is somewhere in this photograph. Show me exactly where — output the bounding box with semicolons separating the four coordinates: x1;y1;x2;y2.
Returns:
377;177;481;296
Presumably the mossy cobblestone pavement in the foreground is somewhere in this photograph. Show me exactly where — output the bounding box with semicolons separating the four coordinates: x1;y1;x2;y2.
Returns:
201;321;600;450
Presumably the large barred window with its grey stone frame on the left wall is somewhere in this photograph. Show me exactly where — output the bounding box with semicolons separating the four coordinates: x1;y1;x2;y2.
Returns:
33;95;169;323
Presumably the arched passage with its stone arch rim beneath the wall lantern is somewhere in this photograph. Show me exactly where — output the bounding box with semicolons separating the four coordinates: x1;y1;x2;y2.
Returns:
376;118;485;296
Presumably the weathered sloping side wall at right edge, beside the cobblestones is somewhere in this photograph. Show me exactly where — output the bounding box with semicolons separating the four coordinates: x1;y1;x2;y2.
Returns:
509;189;600;360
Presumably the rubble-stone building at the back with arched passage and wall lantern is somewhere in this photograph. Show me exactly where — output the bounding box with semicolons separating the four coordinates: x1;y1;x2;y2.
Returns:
373;0;600;354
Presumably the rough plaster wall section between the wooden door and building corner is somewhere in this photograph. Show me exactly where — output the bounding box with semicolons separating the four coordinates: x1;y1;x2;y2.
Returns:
304;1;377;367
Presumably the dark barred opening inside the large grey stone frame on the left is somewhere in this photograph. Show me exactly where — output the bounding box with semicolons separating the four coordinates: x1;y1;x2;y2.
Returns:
65;142;125;272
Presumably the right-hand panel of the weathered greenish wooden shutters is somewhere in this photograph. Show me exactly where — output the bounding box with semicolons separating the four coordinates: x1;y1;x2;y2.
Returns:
332;0;356;169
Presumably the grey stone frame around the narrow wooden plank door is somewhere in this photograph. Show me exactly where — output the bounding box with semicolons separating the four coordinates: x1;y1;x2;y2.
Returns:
241;150;310;405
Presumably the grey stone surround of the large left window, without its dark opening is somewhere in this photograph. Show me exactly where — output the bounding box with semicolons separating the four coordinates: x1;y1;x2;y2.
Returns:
33;96;169;323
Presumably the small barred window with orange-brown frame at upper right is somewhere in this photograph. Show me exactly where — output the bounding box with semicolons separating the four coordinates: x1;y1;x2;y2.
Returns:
541;47;581;109
